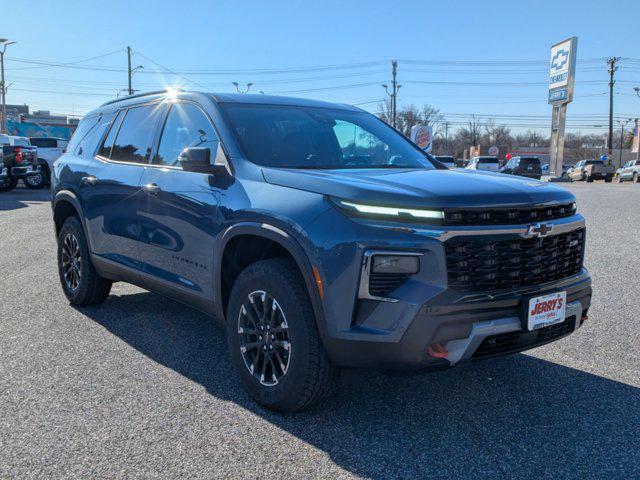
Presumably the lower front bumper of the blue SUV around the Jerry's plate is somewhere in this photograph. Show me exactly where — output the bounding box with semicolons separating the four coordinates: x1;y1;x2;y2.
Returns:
328;270;592;371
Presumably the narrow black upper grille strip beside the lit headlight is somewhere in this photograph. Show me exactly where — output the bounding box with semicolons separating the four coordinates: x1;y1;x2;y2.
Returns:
444;203;576;225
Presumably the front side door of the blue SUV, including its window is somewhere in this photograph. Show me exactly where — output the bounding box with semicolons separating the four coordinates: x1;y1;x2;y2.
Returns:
140;102;222;301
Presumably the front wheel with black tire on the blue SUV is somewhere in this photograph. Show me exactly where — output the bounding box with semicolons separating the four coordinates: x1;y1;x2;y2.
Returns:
227;259;336;412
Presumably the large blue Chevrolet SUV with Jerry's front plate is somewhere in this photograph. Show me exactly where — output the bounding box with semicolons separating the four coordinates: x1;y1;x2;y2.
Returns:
52;91;591;411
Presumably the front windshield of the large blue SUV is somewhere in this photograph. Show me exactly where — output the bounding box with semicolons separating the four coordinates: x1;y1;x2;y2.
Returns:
221;103;435;169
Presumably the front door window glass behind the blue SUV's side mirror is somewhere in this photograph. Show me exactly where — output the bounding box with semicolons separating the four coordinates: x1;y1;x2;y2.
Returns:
154;103;218;166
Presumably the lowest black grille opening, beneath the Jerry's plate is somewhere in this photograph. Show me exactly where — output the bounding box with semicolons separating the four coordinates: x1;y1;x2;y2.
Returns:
471;317;576;359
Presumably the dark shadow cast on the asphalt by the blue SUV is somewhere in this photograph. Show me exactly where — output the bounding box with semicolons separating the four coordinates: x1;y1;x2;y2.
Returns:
79;292;640;479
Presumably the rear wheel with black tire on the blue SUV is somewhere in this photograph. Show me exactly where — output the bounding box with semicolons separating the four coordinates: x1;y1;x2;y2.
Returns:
58;217;112;306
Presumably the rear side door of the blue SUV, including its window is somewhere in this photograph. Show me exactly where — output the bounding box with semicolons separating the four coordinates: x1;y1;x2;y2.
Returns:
83;104;163;270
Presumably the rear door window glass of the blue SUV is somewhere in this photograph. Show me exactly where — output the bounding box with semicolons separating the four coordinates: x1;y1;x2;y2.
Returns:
105;105;161;163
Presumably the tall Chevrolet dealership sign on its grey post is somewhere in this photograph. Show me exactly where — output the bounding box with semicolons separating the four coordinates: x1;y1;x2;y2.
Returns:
549;37;578;177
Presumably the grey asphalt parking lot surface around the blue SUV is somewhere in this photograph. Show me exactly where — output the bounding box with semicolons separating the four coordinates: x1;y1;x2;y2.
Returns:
0;182;640;479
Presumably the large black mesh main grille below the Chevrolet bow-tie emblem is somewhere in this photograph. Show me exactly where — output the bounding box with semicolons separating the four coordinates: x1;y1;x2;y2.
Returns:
445;228;585;292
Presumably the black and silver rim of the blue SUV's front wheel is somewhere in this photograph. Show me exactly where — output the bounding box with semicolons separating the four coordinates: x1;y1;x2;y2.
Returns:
238;290;291;387
